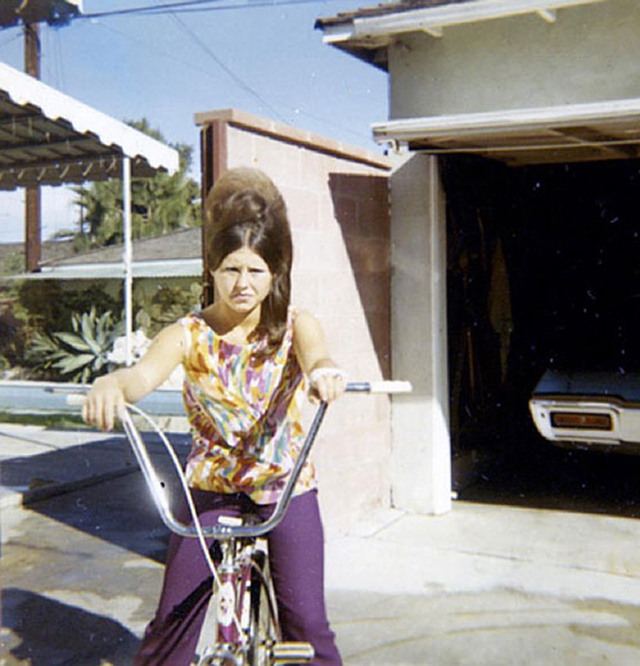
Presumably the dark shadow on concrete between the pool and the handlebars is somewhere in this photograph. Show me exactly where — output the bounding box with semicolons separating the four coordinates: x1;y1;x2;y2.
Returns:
2;434;190;562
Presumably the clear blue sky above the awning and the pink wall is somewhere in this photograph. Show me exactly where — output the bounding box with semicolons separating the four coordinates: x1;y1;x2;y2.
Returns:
0;0;387;242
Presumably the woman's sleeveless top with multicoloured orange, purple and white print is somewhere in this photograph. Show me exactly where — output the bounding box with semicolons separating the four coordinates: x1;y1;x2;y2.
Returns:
180;309;316;504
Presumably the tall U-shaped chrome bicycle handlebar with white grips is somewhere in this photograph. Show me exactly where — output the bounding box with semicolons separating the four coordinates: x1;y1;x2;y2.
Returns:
67;381;412;540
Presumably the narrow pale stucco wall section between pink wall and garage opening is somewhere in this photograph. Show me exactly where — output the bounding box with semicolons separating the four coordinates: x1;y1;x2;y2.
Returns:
391;154;451;514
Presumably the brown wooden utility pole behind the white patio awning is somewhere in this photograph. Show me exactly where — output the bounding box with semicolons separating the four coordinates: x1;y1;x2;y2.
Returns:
24;22;42;273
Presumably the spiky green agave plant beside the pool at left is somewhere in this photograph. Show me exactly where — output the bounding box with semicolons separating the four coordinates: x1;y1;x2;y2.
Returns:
29;307;124;382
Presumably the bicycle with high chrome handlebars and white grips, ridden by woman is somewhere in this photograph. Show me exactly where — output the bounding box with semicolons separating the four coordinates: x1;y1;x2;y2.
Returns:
67;381;411;666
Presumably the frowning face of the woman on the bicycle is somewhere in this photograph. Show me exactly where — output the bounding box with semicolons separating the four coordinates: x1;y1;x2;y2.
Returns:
212;247;273;313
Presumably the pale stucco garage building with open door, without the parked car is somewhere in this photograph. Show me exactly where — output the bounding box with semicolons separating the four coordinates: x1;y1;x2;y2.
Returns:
317;0;640;513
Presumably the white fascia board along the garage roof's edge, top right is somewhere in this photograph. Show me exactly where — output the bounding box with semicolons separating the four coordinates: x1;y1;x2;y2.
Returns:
336;0;606;43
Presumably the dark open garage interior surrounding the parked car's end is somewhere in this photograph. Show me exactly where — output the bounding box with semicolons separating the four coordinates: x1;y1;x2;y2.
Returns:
441;155;640;516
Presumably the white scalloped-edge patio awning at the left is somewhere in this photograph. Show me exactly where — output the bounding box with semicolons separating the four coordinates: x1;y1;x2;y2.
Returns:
0;63;178;190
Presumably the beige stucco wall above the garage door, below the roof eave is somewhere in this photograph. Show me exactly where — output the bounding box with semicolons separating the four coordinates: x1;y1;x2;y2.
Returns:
389;0;640;119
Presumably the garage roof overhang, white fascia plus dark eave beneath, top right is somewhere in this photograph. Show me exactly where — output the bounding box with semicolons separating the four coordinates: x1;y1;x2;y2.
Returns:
316;0;605;69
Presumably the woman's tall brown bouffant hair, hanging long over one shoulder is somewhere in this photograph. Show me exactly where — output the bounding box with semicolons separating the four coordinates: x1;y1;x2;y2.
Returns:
205;167;293;353
